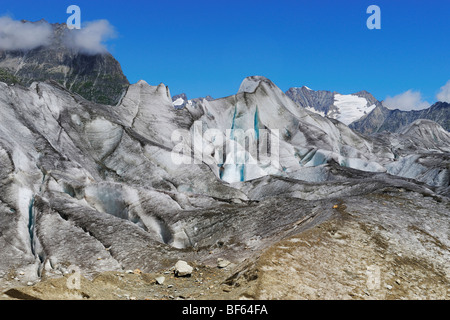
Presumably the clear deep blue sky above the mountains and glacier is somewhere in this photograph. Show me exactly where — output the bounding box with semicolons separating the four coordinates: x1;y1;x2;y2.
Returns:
0;0;450;103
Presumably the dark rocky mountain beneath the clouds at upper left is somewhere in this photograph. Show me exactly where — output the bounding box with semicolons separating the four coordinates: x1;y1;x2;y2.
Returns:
0;24;129;105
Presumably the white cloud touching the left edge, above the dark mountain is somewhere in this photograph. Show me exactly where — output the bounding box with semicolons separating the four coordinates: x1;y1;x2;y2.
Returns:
0;17;52;50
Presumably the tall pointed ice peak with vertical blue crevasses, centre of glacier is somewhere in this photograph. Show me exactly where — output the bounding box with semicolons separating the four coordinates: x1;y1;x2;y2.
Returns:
190;76;394;183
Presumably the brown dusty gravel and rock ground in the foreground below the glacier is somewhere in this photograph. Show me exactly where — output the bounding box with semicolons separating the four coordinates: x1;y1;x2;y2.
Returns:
1;192;450;300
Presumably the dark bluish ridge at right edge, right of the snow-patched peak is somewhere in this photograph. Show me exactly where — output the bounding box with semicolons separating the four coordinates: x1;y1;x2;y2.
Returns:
350;102;450;134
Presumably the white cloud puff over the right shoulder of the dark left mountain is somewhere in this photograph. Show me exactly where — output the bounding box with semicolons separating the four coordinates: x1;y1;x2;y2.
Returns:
65;20;116;55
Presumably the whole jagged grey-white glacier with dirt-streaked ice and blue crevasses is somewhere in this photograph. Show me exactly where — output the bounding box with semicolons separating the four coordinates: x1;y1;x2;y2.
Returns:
0;76;450;292
